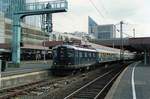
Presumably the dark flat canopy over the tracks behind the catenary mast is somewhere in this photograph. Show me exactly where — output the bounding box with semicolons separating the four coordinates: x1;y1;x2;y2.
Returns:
91;37;150;52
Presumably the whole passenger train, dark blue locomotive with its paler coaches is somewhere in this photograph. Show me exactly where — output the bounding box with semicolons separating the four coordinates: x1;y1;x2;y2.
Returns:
52;45;134;73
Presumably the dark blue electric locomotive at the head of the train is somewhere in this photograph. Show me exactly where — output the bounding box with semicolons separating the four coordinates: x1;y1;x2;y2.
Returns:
52;45;98;72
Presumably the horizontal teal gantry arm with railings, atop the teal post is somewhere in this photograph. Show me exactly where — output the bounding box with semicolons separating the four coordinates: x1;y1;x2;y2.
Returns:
15;0;68;16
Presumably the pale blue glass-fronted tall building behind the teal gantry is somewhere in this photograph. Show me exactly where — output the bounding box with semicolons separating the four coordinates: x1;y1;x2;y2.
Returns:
0;0;49;28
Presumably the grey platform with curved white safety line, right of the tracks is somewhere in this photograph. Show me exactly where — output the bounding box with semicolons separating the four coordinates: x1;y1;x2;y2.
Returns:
105;62;150;99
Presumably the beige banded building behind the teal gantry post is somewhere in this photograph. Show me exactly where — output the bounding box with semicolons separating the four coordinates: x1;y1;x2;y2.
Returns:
0;12;49;60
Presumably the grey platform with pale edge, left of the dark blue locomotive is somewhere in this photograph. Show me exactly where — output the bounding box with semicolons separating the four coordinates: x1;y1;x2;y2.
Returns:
0;60;52;89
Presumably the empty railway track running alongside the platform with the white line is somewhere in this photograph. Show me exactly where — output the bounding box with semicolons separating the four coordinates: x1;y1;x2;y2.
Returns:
64;69;122;99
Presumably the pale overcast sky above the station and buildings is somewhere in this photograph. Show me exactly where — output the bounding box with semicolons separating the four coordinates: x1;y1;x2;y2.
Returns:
27;0;150;36
